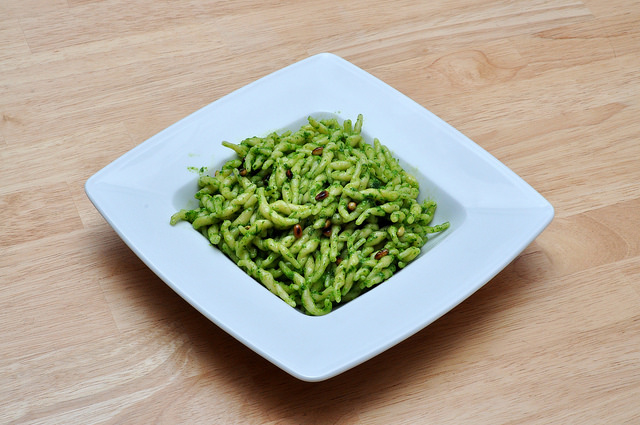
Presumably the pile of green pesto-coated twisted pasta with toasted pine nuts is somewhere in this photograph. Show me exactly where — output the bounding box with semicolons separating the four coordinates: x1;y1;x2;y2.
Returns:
171;115;449;315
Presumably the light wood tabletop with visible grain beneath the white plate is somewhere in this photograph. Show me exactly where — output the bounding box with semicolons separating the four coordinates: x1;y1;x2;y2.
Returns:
0;0;640;424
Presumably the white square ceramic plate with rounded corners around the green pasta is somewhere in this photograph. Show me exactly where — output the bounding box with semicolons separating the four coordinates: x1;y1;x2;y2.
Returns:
85;53;554;381
